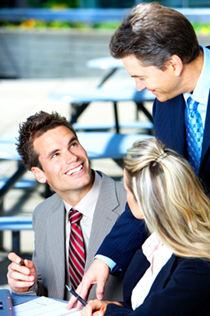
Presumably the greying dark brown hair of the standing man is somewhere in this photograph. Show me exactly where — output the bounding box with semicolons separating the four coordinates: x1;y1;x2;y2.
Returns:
110;2;200;70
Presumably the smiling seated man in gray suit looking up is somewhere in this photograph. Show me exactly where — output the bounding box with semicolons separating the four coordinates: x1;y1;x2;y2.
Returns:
7;111;126;300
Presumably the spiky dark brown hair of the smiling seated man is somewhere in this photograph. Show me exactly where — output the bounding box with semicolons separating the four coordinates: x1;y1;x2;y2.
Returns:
17;111;77;170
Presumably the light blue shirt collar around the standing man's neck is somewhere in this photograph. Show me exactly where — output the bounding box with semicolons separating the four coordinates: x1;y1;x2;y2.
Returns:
183;46;210;106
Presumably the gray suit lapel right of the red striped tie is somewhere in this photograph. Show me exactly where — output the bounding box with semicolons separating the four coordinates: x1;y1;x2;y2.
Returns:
85;173;119;271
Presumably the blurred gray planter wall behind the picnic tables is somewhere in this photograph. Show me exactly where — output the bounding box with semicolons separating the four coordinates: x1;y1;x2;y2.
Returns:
0;29;113;78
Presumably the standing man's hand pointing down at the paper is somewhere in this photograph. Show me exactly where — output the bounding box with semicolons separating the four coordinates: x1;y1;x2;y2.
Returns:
67;259;109;309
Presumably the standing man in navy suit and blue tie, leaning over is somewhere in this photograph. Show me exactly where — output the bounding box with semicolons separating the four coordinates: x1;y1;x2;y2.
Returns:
69;2;210;306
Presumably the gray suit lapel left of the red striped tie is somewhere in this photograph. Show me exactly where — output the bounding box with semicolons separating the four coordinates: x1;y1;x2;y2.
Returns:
46;198;66;297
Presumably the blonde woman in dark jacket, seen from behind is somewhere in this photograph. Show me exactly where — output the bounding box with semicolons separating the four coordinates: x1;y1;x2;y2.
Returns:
81;138;210;316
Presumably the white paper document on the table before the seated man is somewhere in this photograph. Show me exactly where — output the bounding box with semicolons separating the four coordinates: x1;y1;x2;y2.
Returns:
13;296;80;316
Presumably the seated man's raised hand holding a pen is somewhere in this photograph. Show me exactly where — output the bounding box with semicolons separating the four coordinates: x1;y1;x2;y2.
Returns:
7;252;37;293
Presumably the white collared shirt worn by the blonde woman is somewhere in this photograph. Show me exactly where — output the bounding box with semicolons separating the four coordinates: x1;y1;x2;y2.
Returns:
131;233;173;310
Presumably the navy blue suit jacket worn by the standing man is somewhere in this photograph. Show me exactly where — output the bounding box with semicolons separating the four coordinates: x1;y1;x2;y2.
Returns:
97;88;210;273
